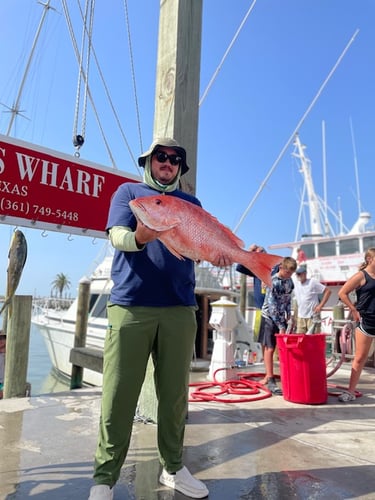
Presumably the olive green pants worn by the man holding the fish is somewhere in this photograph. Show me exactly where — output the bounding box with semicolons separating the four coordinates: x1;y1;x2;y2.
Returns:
94;304;196;486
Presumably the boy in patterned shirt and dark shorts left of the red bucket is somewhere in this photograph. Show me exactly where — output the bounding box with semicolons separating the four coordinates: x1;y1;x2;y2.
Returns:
258;257;297;395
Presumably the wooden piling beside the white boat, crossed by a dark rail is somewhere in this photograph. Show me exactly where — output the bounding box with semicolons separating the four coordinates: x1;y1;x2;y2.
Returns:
70;278;91;389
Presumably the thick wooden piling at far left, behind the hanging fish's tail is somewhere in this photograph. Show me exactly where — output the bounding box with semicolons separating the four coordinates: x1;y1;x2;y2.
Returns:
3;295;32;399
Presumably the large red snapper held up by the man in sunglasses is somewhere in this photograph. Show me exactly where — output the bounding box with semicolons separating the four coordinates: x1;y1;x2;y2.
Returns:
129;195;282;285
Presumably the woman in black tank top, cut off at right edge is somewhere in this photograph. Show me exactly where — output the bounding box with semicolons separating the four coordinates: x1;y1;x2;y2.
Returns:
338;248;375;403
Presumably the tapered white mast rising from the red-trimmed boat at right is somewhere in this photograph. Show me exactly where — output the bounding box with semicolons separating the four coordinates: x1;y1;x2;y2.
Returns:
293;134;322;236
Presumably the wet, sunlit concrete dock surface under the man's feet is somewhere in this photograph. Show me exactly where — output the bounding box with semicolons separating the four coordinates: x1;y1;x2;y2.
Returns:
0;366;375;500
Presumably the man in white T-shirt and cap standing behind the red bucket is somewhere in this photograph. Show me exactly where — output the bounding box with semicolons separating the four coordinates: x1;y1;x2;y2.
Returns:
294;265;332;333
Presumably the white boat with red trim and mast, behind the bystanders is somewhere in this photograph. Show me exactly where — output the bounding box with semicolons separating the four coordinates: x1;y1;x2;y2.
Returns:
269;134;375;333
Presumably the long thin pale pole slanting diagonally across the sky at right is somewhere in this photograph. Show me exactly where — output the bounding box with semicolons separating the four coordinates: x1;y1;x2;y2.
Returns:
233;29;359;233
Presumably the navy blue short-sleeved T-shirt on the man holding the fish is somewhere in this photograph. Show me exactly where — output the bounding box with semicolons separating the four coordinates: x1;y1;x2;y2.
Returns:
106;182;201;307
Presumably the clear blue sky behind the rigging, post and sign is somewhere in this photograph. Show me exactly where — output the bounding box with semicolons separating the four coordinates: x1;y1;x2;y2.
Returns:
0;0;375;295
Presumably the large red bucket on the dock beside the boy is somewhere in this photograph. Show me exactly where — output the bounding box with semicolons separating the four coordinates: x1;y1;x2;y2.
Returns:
276;333;328;404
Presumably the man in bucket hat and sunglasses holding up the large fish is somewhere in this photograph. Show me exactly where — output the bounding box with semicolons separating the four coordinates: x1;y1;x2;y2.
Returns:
89;138;232;500
